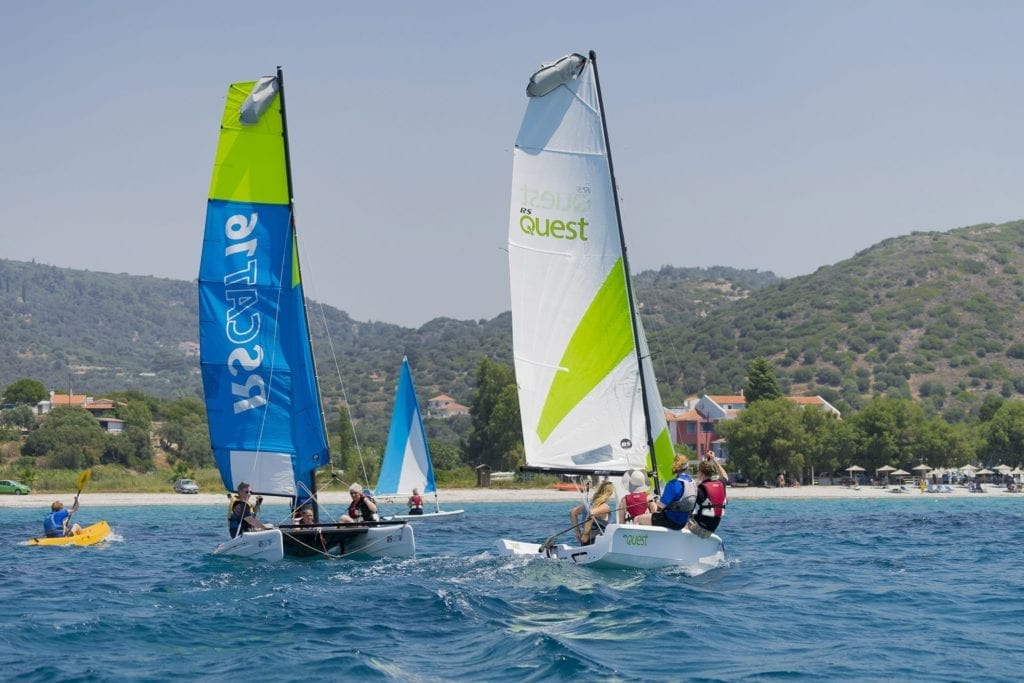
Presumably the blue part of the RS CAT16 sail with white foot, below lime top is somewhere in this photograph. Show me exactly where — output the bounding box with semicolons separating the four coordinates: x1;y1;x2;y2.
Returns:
199;199;329;498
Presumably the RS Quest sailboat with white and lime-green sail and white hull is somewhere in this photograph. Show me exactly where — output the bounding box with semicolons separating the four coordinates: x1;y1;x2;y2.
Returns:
498;52;725;572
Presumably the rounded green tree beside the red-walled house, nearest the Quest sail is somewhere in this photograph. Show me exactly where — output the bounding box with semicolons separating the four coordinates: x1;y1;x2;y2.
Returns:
718;398;810;481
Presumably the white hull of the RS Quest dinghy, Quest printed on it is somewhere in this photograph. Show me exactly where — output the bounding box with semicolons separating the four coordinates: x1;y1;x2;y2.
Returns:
498;524;725;573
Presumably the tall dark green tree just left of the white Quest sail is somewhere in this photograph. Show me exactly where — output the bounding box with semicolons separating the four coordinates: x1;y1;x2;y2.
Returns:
466;358;522;468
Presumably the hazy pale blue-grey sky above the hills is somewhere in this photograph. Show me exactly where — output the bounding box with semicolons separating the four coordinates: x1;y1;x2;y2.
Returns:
0;0;1024;327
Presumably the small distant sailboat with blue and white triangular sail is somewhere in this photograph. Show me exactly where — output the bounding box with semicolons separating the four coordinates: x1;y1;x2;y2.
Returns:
374;357;464;521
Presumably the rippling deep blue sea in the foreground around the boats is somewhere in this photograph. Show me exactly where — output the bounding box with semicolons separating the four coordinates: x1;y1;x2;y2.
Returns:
0;492;1024;681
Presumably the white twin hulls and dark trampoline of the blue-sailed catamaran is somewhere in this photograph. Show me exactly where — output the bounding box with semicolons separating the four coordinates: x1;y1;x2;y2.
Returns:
213;523;416;562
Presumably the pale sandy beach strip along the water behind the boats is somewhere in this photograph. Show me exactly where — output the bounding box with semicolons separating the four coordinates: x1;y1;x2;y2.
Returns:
0;485;1024;509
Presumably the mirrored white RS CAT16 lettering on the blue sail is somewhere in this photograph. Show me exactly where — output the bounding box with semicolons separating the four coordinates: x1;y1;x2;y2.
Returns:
224;213;266;415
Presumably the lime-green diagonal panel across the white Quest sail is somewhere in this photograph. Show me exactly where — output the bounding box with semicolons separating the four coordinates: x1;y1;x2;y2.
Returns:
537;259;634;441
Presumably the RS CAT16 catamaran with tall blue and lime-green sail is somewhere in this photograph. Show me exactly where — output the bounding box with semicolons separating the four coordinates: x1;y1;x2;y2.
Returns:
199;69;416;560
